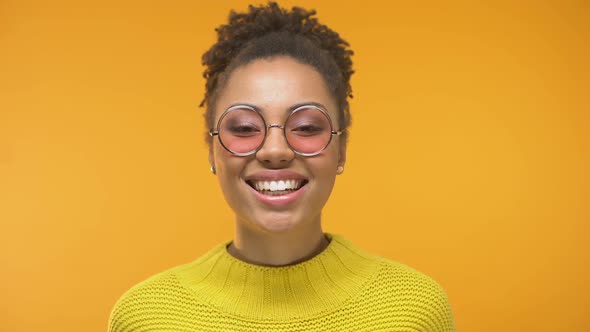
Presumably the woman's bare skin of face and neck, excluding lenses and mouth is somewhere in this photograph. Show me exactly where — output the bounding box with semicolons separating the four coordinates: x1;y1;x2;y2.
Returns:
209;56;346;266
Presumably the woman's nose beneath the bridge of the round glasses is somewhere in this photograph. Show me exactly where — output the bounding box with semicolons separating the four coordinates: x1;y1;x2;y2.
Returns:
256;126;295;168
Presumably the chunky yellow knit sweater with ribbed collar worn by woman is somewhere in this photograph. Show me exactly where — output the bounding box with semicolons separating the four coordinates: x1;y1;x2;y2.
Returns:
109;233;455;332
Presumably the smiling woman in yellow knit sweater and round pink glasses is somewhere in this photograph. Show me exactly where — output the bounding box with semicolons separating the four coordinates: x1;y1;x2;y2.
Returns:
110;3;455;331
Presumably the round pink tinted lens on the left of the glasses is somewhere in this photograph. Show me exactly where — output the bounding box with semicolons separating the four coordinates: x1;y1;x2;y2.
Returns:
219;108;265;153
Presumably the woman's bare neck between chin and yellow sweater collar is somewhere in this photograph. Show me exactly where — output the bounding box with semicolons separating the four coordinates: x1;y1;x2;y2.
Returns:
227;222;329;266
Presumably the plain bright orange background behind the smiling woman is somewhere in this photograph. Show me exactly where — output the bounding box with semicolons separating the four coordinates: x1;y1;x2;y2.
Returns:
0;0;590;331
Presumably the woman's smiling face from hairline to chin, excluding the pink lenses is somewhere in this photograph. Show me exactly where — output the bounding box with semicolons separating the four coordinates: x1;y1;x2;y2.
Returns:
209;56;346;233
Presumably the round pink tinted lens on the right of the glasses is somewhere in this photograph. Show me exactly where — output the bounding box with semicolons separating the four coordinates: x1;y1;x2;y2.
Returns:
285;107;332;154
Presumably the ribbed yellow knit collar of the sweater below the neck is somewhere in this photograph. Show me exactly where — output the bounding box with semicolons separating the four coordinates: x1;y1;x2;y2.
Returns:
175;233;380;321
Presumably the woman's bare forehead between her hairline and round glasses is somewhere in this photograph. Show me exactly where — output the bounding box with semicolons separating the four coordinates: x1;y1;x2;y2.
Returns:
215;56;336;120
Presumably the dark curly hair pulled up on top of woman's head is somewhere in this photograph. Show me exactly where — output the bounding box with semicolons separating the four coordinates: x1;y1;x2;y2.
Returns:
200;2;354;144
